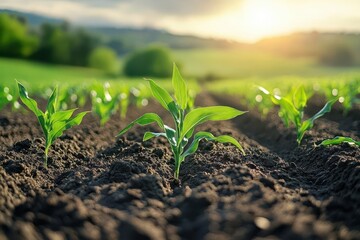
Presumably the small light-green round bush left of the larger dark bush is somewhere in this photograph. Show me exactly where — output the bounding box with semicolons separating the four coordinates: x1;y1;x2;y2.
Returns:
89;47;119;75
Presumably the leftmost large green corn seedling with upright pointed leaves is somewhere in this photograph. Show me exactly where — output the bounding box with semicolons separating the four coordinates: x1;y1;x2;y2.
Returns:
18;82;88;168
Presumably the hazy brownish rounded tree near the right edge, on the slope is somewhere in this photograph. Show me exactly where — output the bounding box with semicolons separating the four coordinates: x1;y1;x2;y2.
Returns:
319;44;355;67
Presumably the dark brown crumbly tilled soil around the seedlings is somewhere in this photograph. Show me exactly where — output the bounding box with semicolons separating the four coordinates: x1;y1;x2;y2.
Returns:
0;95;360;240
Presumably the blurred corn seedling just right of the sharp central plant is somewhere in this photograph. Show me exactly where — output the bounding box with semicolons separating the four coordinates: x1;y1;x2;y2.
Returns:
259;86;337;145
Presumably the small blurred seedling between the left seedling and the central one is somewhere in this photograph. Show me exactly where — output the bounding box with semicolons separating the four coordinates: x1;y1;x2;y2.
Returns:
91;83;120;126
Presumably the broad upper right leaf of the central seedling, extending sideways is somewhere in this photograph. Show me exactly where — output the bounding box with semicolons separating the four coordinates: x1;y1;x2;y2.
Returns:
180;106;245;138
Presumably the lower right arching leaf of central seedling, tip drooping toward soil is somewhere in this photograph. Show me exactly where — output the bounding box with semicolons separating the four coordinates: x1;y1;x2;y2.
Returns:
183;132;245;157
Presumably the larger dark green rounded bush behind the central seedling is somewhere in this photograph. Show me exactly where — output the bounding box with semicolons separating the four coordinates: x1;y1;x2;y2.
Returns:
124;46;173;77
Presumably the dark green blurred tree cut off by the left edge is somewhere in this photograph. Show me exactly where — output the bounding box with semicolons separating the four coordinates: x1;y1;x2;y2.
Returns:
0;14;38;58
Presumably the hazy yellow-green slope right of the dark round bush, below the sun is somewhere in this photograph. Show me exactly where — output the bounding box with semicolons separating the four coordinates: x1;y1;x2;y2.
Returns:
173;49;360;79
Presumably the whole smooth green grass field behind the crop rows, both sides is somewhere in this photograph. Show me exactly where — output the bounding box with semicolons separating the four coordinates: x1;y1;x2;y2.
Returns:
0;49;360;93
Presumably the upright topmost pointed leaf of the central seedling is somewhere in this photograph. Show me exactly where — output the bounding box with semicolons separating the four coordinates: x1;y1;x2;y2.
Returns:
172;63;188;110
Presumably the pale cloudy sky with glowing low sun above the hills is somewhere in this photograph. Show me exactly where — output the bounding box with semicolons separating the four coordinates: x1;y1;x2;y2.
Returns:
0;0;360;42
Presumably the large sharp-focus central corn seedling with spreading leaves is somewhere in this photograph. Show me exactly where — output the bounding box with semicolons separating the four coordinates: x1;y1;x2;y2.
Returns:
119;64;245;179
